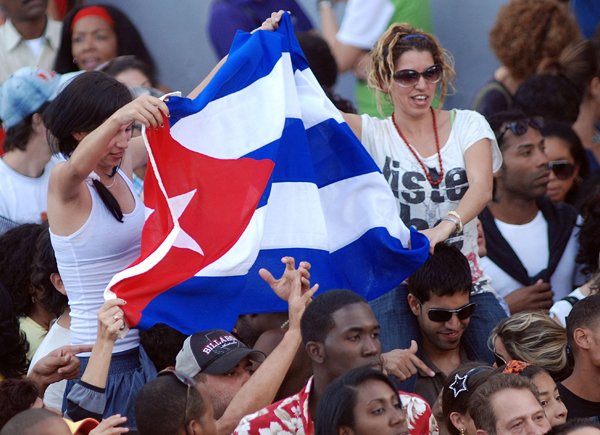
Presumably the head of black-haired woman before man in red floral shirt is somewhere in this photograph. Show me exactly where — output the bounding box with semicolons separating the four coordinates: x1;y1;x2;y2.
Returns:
315;367;408;435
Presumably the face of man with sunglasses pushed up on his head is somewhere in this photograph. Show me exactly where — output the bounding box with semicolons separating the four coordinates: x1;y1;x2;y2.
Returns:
500;127;550;198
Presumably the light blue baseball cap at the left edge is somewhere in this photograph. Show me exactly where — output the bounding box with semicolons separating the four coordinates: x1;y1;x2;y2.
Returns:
0;66;83;129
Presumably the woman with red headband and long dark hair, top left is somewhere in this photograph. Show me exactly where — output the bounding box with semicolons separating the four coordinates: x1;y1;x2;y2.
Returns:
54;5;154;73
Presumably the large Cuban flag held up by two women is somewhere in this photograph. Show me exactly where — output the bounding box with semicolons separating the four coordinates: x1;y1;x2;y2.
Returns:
106;14;429;334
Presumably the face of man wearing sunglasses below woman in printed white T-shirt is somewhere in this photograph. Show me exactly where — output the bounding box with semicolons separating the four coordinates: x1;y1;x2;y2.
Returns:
408;292;470;351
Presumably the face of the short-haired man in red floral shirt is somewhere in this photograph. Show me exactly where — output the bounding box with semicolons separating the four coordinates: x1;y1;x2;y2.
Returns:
323;302;381;378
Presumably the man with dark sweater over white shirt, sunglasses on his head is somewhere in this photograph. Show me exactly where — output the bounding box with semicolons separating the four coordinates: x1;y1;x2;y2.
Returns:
480;111;583;314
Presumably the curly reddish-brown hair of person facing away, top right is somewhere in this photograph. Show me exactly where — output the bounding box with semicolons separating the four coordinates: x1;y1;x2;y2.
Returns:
490;0;580;80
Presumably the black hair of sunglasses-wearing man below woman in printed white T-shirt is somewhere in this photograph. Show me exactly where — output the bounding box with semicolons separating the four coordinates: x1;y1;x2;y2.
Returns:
408;243;472;303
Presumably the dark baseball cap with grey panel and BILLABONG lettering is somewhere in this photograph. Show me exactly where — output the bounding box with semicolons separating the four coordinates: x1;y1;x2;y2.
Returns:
175;329;265;377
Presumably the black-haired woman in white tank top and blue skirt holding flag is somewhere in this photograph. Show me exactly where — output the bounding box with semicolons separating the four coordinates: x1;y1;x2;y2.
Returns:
44;71;169;425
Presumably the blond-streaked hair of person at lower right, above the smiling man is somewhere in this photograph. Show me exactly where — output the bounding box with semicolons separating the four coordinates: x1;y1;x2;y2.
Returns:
488;311;571;380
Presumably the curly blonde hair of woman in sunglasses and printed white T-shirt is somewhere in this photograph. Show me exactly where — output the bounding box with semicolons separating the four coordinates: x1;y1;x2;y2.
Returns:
368;23;456;116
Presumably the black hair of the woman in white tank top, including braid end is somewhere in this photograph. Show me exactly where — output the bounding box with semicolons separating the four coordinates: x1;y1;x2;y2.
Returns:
43;71;132;222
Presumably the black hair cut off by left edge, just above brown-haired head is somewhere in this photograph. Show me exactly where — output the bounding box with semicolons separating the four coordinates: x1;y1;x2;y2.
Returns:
0;283;29;380
